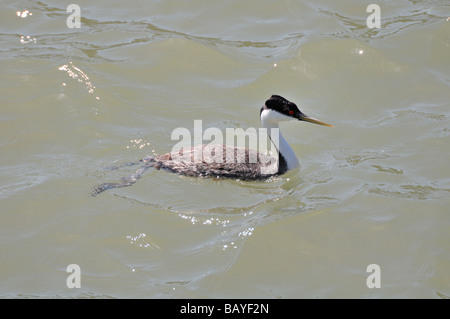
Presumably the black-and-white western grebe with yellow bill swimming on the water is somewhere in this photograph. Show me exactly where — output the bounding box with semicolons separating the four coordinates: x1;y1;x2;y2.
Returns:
91;95;332;196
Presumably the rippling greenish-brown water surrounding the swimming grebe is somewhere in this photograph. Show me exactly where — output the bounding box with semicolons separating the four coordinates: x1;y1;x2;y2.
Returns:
0;0;450;298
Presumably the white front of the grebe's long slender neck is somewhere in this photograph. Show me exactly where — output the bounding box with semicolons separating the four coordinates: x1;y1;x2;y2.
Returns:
261;110;300;171
